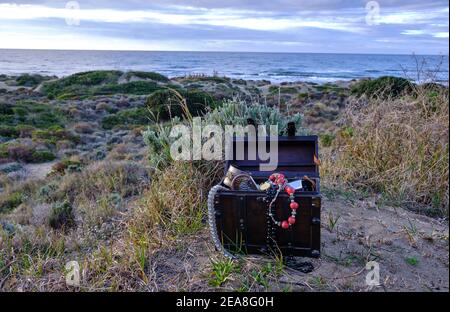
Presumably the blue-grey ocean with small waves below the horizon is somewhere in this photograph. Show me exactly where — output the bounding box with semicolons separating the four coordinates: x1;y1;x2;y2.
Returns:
0;50;449;83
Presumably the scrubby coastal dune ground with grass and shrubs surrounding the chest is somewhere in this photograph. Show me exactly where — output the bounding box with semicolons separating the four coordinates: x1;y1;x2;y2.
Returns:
0;71;449;291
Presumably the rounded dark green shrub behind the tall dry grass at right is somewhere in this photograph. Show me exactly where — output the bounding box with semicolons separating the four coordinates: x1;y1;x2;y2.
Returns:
351;76;413;99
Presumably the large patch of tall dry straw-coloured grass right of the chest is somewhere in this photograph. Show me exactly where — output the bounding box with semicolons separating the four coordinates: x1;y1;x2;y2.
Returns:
322;84;449;216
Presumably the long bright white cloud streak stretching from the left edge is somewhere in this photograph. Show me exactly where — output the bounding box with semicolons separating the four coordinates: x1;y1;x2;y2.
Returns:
0;3;363;32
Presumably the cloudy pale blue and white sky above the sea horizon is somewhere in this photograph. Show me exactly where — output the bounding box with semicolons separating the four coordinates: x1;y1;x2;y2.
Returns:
0;0;449;55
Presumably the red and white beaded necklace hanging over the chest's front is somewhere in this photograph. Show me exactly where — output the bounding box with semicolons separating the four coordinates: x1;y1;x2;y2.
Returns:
267;173;299;230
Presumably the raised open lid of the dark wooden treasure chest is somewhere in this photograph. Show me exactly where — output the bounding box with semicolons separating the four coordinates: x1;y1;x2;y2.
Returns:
225;135;319;177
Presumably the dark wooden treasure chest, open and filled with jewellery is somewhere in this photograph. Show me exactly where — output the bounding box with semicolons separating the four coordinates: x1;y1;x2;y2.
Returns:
208;135;321;258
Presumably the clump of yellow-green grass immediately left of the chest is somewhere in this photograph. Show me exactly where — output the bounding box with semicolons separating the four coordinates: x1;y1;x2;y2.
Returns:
130;162;217;238
